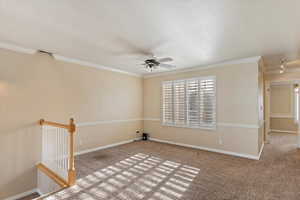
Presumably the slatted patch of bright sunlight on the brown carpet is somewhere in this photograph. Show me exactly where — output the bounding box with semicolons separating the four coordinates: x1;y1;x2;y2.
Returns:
46;153;200;200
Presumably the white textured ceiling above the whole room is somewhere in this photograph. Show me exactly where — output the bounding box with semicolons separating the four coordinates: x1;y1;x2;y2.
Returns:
0;0;300;74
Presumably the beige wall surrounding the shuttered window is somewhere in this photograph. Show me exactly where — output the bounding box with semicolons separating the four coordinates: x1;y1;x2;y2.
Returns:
144;63;260;156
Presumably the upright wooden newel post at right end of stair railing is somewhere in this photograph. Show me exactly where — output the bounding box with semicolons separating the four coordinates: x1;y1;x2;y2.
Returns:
68;118;76;186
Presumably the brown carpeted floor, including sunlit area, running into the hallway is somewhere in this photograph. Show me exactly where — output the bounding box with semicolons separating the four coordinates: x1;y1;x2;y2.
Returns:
22;133;300;200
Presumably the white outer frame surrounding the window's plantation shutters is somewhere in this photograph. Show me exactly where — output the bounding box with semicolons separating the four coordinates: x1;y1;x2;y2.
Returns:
160;76;217;130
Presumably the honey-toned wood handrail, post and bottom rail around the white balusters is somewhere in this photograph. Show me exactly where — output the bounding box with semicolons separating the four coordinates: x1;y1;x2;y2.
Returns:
37;118;76;187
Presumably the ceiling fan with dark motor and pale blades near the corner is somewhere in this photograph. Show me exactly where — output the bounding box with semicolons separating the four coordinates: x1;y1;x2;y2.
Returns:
142;56;175;72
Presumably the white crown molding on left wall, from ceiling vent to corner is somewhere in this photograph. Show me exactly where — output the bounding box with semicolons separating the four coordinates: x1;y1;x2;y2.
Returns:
53;54;142;77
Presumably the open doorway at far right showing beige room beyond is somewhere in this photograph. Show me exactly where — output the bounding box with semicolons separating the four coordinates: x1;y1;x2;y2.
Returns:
266;81;300;148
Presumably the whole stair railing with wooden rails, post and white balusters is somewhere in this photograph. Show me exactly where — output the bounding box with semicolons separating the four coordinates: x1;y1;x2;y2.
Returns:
37;118;76;187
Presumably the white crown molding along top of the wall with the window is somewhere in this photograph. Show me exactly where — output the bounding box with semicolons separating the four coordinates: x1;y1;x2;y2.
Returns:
143;56;262;79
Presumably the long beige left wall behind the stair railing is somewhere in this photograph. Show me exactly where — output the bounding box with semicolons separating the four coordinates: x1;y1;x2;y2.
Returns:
0;49;143;199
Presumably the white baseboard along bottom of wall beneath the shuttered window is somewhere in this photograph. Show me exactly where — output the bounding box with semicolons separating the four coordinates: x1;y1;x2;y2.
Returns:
149;138;262;160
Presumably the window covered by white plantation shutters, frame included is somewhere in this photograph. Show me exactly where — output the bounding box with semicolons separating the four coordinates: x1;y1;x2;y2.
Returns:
162;77;216;129
